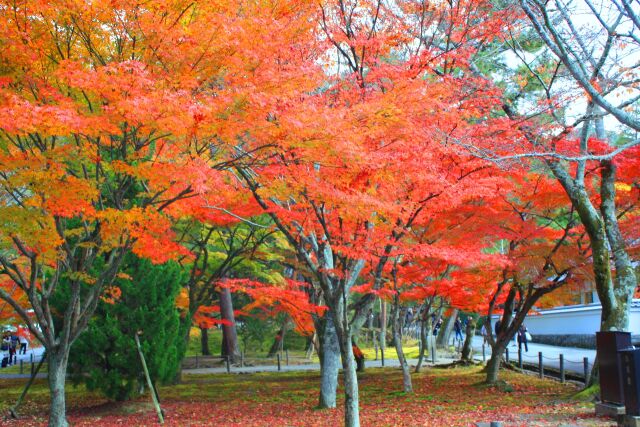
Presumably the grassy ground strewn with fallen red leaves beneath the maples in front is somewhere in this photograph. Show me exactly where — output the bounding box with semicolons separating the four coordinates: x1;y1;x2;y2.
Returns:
0;366;615;427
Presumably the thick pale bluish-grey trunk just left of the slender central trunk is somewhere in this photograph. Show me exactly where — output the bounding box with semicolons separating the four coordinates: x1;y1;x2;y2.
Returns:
318;313;340;408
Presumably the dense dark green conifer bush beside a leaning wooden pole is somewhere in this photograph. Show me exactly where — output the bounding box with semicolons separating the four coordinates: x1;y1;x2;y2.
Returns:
68;255;185;400
